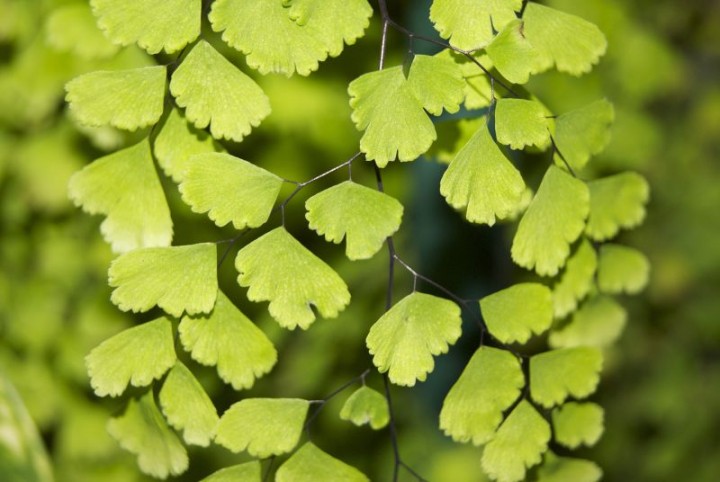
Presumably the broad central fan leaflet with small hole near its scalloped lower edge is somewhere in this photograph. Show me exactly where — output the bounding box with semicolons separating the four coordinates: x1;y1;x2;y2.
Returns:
235;227;350;330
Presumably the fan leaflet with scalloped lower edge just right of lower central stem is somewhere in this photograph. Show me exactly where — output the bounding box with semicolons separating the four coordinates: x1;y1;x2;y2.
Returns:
366;292;462;387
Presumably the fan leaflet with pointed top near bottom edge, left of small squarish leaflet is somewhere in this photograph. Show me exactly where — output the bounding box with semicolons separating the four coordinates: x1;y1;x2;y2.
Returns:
482;400;550;482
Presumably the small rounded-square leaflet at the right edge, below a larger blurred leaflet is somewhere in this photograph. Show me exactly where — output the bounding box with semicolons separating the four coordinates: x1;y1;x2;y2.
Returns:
597;243;650;294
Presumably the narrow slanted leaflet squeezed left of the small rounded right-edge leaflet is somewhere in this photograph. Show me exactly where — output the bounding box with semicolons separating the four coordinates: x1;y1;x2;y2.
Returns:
553;238;597;318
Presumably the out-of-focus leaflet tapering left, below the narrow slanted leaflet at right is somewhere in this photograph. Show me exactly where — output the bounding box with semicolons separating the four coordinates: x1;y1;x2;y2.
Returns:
548;296;627;348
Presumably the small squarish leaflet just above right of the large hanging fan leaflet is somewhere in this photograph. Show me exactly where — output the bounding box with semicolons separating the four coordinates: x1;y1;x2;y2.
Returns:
495;99;550;149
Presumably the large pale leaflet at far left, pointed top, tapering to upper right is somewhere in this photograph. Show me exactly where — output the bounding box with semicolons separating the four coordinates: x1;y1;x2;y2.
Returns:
68;139;173;253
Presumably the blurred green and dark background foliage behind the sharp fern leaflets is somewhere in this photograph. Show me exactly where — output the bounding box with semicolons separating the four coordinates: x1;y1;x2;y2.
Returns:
0;0;720;482
